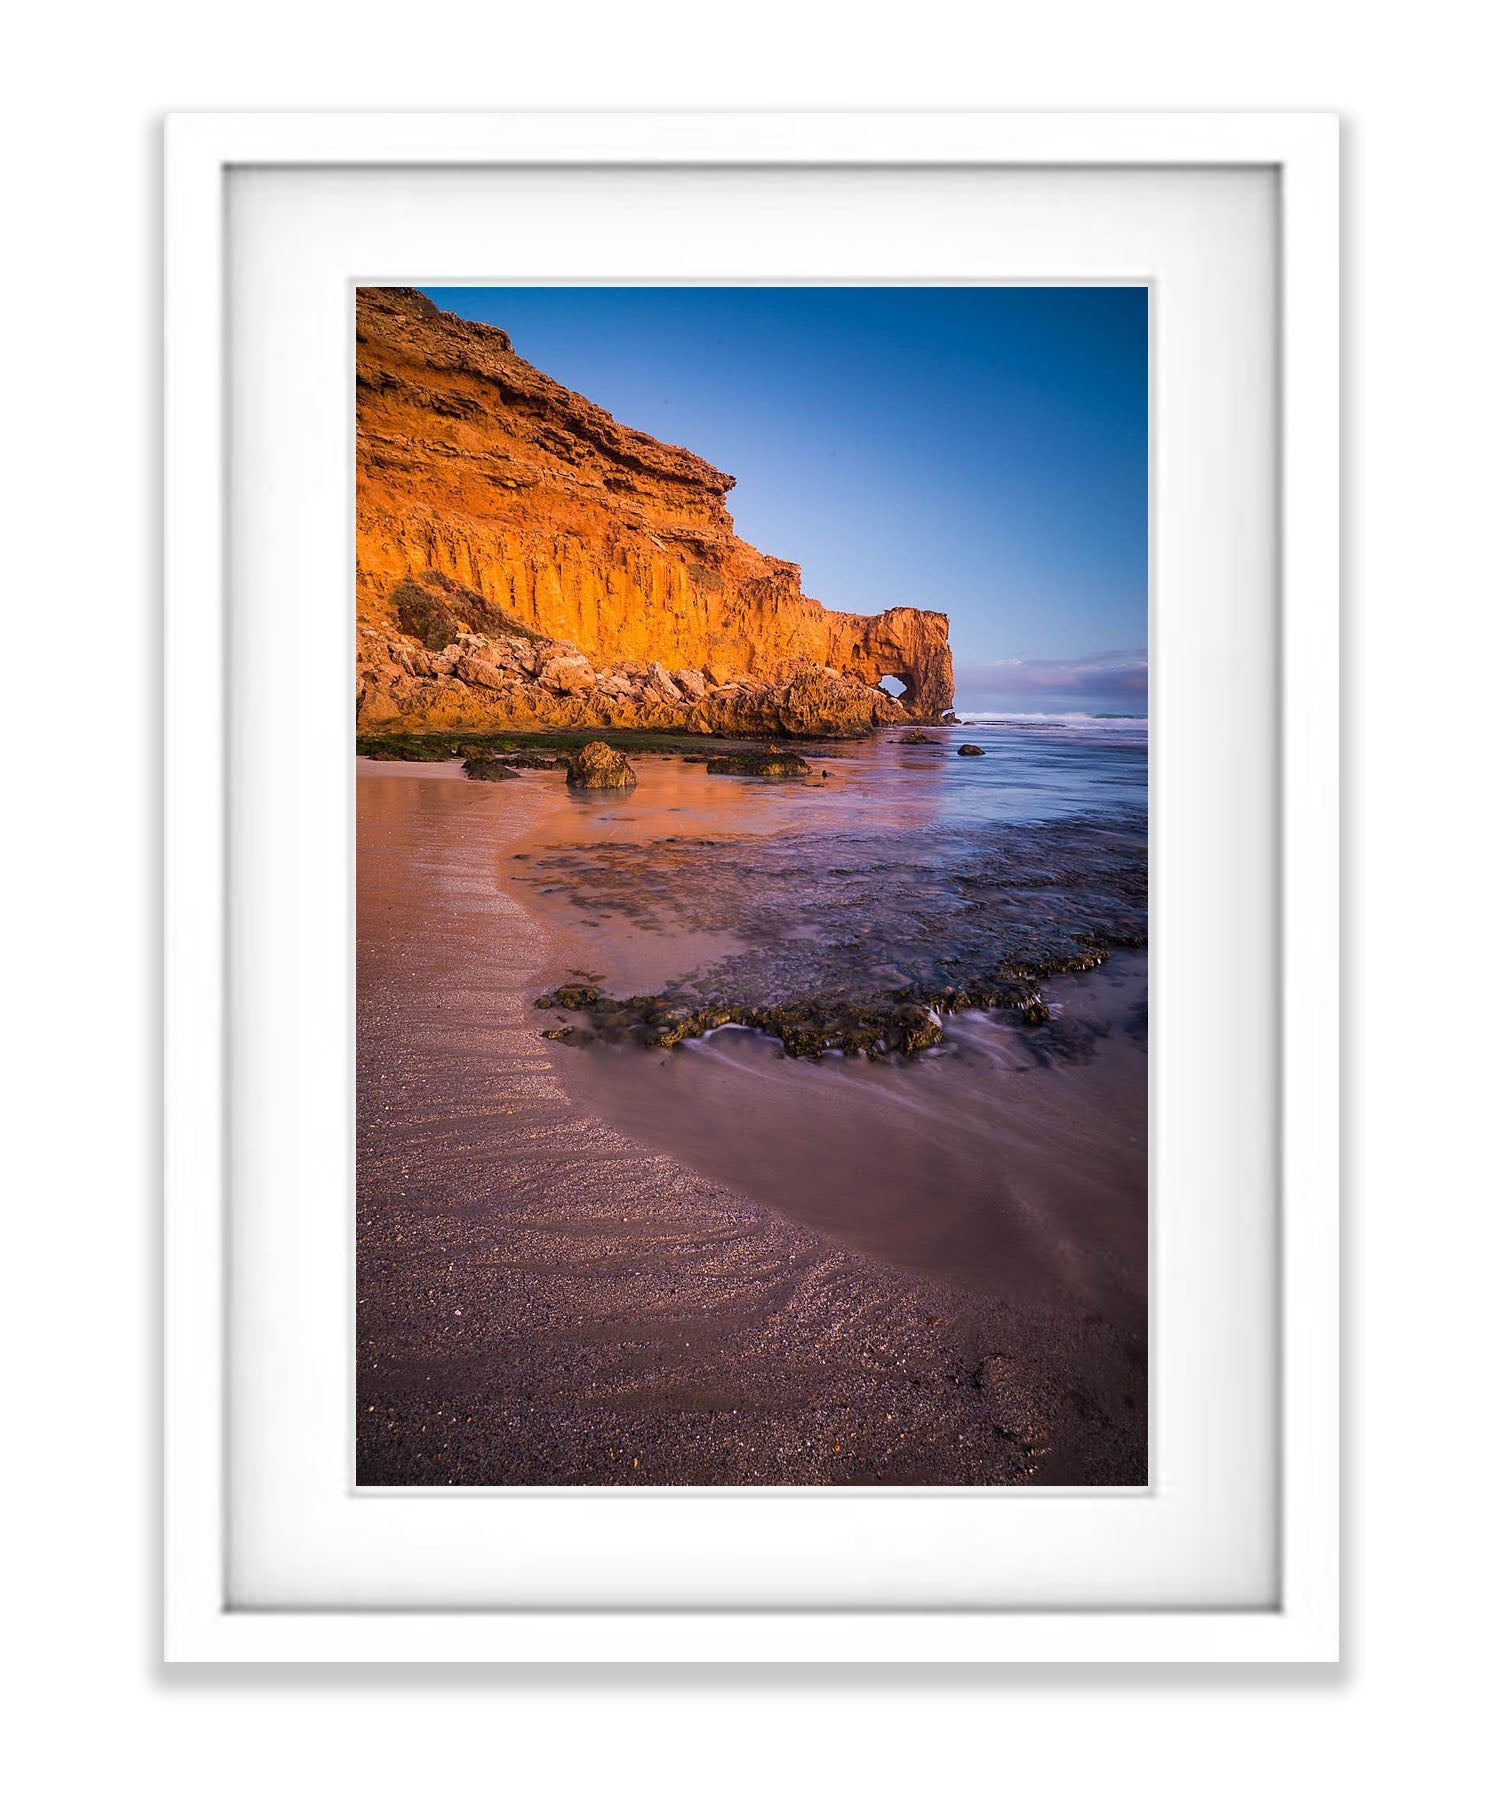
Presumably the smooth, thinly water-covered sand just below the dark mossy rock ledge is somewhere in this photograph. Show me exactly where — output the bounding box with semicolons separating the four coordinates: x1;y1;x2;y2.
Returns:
558;956;1145;1330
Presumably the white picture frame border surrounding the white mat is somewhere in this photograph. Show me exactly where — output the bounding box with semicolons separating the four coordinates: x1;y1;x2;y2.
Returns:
164;113;1338;1663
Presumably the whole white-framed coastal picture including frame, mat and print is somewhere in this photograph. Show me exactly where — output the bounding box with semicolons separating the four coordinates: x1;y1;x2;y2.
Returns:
164;113;1338;1663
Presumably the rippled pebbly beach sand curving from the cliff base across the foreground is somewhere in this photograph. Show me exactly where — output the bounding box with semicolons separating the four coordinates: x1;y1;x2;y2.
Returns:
358;765;1145;1485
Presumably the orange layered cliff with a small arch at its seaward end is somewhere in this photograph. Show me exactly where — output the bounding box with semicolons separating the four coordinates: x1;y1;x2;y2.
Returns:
357;288;953;736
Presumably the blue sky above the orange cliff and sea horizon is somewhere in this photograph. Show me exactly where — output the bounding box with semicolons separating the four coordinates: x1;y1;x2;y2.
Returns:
423;288;1147;713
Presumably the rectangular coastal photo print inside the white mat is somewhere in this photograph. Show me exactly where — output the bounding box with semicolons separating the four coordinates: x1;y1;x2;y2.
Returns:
353;286;1149;1489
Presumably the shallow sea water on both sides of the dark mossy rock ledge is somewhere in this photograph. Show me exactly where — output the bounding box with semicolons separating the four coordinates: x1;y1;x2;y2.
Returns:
499;715;1147;1328
